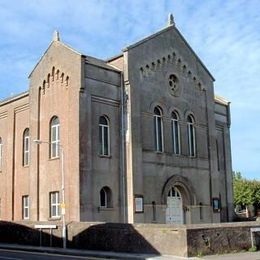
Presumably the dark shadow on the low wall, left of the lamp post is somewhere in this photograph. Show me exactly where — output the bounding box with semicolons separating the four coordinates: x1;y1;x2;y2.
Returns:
0;221;62;247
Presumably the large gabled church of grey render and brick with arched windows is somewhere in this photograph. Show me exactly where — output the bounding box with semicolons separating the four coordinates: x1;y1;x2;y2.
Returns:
0;15;233;224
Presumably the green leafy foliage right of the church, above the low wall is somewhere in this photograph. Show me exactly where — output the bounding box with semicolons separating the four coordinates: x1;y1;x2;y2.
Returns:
233;172;260;206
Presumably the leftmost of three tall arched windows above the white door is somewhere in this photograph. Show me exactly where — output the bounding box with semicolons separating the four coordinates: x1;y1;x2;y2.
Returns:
153;106;164;152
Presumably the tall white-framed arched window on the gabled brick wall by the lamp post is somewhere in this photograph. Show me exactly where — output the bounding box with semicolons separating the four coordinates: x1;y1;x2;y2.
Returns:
50;116;60;158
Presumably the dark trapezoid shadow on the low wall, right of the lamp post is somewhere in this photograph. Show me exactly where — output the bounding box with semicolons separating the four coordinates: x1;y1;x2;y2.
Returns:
68;223;160;255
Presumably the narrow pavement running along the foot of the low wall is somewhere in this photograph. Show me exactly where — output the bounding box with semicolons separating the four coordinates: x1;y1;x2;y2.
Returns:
0;243;260;260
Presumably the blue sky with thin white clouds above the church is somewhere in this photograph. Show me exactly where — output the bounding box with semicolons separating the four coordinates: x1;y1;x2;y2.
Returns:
0;0;260;179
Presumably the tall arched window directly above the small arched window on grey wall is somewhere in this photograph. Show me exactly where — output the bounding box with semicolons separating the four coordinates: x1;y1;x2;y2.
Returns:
99;116;110;156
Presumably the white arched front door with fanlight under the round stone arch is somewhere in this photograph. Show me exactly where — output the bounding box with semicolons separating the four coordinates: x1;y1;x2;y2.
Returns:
166;187;184;224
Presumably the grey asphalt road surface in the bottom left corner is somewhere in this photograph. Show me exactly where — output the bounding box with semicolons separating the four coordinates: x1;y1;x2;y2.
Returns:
0;249;111;260
